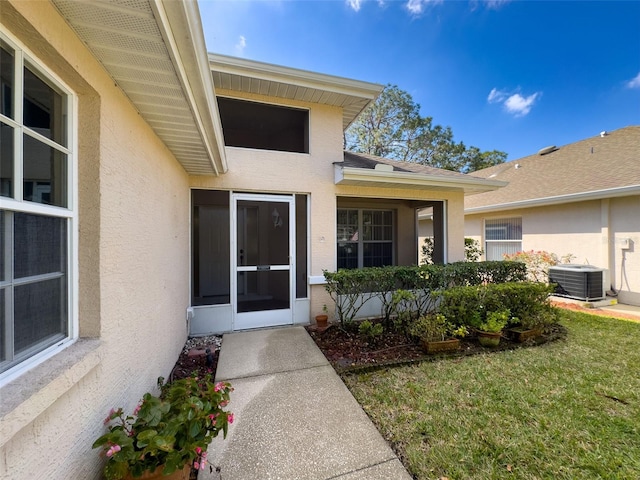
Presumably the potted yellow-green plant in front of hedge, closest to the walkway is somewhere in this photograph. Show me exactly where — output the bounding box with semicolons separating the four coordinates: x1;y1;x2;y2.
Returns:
410;313;468;354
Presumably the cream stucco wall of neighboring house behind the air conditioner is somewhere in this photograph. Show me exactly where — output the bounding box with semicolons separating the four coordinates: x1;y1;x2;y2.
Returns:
465;196;640;305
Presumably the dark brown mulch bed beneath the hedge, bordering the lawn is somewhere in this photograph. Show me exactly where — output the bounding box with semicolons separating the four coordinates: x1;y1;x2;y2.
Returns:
307;324;567;373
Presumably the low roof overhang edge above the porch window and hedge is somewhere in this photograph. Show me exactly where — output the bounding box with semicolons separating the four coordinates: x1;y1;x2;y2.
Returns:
334;164;507;195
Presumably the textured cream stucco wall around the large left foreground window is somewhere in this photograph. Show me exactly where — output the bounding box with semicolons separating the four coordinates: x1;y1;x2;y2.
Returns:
0;2;189;480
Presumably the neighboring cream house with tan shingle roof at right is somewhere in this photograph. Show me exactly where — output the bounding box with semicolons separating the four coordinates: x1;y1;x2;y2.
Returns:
465;126;640;305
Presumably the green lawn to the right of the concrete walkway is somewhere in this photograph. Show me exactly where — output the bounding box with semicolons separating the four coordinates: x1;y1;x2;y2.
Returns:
344;312;640;480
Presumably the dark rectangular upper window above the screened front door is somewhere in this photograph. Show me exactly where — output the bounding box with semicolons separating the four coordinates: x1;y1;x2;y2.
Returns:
218;98;309;153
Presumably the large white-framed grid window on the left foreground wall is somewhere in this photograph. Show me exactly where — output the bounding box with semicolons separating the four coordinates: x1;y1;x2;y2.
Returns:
0;33;75;378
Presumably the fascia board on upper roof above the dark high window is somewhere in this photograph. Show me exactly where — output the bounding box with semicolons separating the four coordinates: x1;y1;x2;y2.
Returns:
209;53;384;100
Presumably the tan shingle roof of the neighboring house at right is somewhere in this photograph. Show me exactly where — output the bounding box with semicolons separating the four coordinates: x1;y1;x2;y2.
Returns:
465;126;640;212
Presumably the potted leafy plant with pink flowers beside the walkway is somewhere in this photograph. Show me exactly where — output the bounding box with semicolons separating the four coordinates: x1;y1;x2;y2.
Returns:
93;375;233;480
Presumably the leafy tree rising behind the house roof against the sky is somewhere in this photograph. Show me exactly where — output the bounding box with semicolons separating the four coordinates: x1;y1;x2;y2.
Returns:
345;85;507;173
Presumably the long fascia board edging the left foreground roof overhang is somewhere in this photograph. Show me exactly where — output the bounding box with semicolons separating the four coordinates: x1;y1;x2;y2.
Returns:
150;0;228;175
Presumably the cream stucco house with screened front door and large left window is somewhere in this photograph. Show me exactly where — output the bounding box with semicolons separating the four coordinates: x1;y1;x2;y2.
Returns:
0;0;504;479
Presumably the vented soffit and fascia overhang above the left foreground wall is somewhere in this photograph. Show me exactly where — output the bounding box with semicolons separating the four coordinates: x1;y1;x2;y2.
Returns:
52;0;227;175
